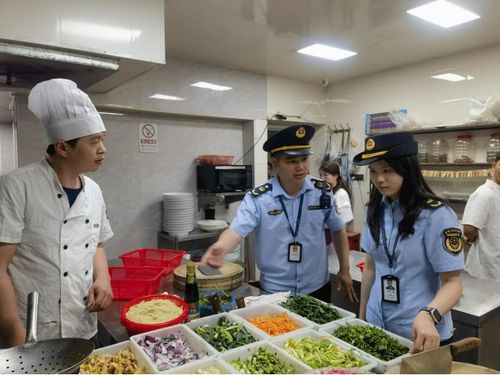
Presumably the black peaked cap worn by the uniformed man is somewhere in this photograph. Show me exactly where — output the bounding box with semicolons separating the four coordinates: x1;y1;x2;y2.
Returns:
263;125;315;156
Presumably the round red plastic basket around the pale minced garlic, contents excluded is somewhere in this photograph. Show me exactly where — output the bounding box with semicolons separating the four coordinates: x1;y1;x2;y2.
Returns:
120;294;188;335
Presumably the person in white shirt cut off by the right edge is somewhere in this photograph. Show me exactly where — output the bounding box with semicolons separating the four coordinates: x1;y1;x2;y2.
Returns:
462;152;500;280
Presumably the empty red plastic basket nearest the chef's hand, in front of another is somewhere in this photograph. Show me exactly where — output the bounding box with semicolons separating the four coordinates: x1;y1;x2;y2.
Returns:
109;267;165;300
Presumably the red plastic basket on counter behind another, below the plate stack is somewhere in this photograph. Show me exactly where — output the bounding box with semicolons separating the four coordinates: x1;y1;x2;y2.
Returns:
120;249;186;275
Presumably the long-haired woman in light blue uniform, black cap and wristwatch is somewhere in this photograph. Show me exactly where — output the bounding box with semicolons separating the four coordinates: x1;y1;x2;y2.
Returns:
354;132;464;353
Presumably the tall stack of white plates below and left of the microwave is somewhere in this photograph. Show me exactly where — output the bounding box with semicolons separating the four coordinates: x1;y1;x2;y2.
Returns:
162;193;196;236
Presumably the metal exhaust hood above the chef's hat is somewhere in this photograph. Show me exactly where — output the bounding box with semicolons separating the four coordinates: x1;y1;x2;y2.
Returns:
0;40;119;89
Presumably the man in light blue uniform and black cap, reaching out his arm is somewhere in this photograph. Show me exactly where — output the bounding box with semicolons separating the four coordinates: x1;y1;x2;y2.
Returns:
202;125;357;302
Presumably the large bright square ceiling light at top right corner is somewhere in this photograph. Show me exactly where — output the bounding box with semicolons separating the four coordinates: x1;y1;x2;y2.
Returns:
406;0;480;28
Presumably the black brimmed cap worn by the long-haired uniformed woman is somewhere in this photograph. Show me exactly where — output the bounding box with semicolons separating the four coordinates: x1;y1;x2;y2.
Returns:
353;132;418;165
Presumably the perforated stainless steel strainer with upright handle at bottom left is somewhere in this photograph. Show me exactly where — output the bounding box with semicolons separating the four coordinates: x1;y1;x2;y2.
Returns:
0;292;94;374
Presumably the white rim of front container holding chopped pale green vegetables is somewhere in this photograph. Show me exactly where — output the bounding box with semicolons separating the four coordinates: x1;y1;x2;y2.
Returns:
269;328;377;371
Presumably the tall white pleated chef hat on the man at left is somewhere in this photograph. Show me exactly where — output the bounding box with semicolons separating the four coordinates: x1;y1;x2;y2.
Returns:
28;78;106;144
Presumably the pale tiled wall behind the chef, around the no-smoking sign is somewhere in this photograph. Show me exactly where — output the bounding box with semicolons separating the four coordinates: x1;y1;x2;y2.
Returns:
19;98;243;258
